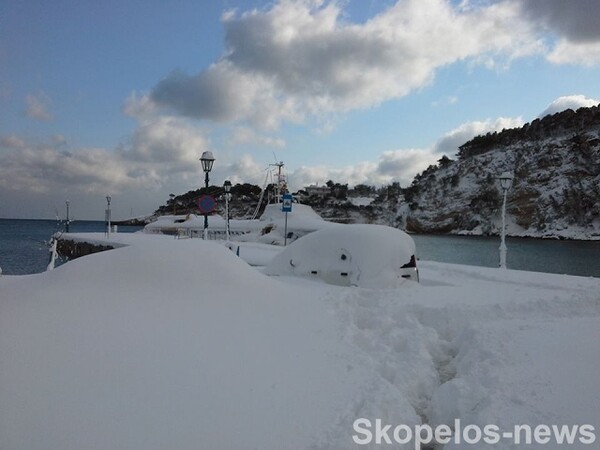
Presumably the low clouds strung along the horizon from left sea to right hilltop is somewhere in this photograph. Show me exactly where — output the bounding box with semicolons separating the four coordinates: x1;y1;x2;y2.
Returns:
0;89;599;217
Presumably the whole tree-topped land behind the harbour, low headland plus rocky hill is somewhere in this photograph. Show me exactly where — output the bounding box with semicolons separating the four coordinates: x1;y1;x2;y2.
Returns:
149;106;600;239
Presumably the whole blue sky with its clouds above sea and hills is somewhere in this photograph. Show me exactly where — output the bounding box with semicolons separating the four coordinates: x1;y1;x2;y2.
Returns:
0;0;600;220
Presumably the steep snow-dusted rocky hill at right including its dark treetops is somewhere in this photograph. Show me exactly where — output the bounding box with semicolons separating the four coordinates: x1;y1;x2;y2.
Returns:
405;107;600;239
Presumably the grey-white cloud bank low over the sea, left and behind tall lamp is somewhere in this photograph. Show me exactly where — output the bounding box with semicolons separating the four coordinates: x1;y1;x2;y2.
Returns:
0;126;276;219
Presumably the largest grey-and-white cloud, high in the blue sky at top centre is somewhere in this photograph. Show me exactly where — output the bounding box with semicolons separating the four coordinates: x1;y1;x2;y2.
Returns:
151;0;541;129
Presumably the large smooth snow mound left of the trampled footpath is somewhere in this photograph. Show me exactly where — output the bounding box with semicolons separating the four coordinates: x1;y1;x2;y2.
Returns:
0;243;376;450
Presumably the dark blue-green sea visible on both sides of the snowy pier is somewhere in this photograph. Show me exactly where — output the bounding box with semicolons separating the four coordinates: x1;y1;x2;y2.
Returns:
0;219;600;277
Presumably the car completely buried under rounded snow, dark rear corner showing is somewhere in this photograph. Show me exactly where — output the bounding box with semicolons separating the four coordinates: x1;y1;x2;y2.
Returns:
265;224;419;288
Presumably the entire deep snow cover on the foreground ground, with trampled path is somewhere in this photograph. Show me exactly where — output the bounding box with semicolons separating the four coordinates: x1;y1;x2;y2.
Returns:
0;234;600;450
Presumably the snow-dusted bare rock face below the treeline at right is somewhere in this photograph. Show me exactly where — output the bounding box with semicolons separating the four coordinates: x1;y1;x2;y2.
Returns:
409;126;600;241
